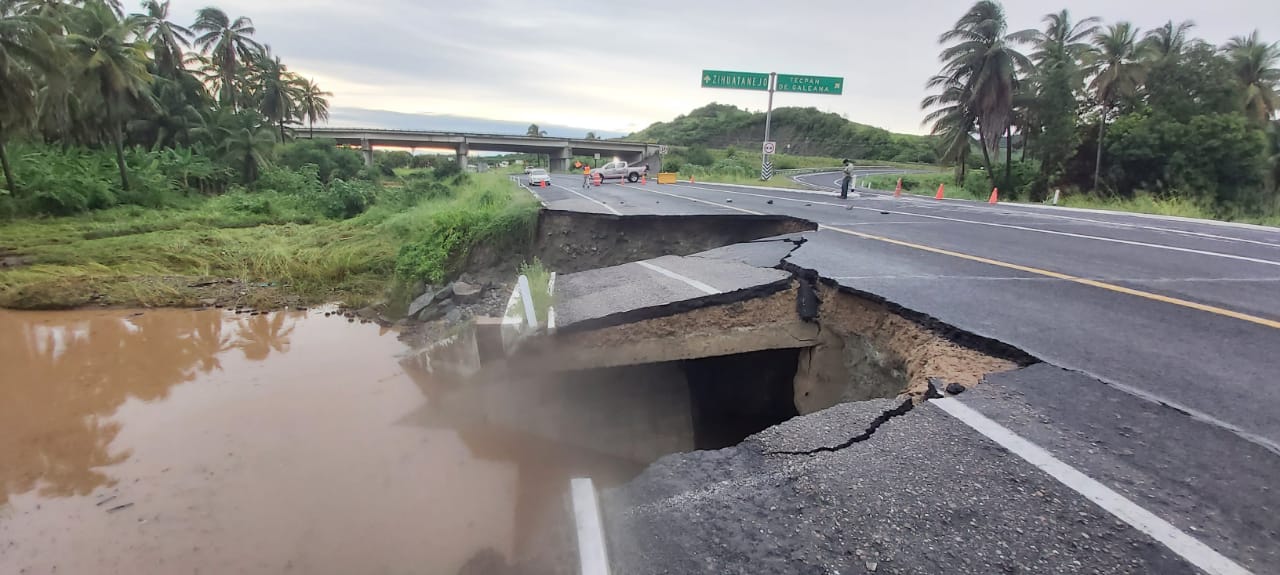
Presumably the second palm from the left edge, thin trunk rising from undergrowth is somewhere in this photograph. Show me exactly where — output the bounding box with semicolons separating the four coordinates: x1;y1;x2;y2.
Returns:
67;0;152;190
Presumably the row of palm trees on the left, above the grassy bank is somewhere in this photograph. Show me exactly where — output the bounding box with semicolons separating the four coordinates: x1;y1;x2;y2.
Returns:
0;0;332;192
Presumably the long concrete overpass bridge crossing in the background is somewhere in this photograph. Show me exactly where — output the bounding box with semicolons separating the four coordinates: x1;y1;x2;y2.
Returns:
297;128;658;172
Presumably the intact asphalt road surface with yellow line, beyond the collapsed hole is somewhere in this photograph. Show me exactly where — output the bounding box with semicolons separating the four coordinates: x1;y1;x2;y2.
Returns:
524;173;1280;574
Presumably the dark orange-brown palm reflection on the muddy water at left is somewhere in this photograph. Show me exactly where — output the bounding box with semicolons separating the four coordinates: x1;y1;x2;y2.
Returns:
0;310;291;503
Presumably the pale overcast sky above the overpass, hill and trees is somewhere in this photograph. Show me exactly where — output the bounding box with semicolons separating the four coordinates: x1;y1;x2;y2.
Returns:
165;0;1280;133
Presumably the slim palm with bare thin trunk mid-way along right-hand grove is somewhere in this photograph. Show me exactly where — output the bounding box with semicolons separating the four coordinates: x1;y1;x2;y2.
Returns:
1089;22;1147;190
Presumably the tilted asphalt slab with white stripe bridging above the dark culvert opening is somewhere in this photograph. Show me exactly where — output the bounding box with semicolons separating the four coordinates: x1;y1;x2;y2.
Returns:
556;256;791;332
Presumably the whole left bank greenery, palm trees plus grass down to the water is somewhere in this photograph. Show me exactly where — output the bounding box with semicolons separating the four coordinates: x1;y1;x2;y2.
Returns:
0;0;536;307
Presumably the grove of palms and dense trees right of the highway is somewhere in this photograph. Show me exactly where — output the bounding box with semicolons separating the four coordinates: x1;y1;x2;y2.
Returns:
922;0;1280;213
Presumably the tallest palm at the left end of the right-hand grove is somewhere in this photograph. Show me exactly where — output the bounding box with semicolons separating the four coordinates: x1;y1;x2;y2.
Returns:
938;0;1036;186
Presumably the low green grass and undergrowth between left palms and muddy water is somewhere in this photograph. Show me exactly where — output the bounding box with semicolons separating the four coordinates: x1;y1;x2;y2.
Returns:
0;173;538;307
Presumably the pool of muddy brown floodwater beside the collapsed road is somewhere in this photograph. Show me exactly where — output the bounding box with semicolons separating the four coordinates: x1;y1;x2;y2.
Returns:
0;310;639;574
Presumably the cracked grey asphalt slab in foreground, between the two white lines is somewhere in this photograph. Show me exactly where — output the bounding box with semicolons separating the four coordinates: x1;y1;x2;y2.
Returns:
602;401;1197;574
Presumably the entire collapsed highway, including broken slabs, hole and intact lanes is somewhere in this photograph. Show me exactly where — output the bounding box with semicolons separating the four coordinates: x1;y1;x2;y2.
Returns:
422;174;1280;572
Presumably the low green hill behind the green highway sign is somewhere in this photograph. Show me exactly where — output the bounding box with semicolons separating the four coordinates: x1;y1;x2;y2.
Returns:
627;102;937;164
